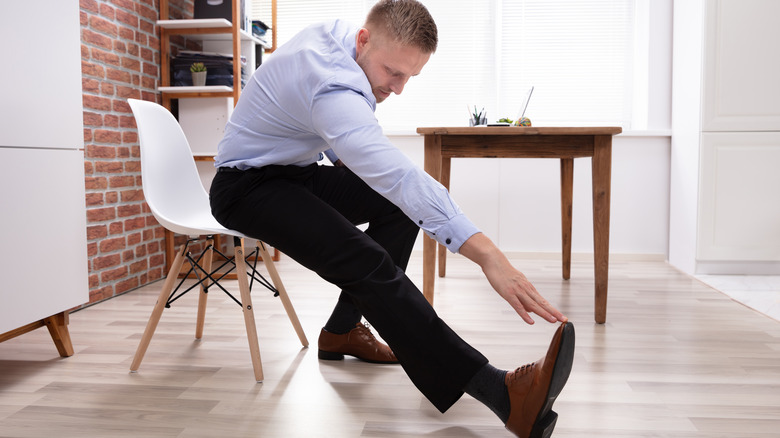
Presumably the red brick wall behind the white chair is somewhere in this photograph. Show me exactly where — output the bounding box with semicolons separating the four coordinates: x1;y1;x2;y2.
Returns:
79;0;197;303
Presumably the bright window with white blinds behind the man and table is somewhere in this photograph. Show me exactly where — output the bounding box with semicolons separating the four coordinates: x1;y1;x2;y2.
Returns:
253;0;635;132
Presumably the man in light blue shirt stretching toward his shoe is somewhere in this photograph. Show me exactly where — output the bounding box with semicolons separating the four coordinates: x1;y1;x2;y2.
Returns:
211;0;574;437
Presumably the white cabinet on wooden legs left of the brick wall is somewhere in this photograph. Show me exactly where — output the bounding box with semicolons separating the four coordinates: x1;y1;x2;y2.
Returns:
0;0;89;350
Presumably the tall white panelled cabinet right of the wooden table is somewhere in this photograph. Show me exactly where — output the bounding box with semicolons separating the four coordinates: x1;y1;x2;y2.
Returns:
669;0;780;274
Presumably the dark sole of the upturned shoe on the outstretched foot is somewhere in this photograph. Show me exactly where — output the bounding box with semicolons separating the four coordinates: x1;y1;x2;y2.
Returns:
528;322;574;438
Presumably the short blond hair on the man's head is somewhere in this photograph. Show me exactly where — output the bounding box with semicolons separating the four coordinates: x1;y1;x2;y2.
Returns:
365;0;439;53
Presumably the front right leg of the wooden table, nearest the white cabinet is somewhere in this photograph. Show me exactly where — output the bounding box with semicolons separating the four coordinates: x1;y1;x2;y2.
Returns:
592;135;612;324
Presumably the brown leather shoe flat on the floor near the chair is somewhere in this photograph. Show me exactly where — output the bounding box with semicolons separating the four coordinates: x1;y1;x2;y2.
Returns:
317;323;398;363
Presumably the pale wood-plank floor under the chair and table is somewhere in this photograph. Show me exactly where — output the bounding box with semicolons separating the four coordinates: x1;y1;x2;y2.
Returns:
0;255;780;438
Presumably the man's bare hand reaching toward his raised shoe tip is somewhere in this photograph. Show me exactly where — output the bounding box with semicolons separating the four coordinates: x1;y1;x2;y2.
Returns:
459;233;568;324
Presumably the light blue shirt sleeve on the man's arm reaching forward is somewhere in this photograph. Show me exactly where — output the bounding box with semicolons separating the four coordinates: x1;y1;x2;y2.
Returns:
311;86;479;253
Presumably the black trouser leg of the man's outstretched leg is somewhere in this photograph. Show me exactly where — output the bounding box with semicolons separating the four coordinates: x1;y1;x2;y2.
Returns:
212;166;487;411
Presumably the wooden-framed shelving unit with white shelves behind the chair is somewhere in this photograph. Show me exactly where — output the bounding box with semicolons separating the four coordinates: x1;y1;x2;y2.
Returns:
157;0;278;271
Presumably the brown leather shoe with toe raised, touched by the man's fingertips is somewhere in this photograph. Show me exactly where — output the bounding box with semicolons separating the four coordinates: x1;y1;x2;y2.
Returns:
504;322;574;438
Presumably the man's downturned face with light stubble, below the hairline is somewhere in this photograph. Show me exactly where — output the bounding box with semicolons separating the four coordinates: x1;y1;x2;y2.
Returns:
355;28;431;103
